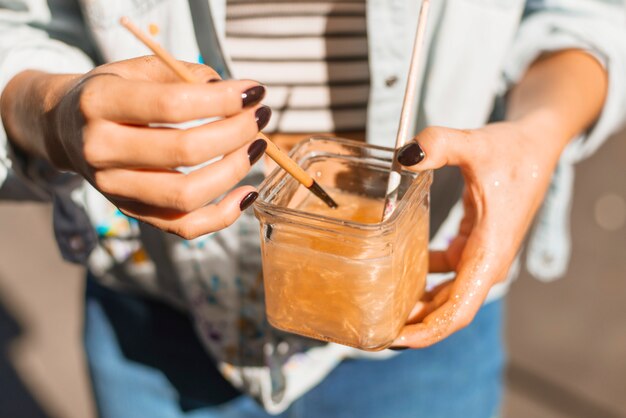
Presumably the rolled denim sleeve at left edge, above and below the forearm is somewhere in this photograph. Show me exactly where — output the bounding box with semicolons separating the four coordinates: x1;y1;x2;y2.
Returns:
0;0;93;200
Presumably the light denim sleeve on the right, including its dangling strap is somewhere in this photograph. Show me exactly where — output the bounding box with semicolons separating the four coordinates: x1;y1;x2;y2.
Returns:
505;0;626;281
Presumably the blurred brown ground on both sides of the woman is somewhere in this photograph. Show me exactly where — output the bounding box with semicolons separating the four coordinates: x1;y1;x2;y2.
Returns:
0;128;626;418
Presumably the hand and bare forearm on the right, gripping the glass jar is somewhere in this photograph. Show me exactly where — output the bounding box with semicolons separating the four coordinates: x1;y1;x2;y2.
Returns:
395;50;608;348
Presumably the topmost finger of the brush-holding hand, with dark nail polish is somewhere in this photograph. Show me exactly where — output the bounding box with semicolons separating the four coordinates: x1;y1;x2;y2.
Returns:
80;75;265;125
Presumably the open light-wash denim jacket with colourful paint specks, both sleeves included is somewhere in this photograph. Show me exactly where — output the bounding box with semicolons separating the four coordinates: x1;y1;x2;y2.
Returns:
0;0;626;413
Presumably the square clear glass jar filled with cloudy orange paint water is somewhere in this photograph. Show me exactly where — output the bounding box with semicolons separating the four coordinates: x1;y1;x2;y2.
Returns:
254;137;432;351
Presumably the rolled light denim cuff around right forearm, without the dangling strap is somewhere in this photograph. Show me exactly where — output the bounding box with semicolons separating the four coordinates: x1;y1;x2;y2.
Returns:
505;0;626;162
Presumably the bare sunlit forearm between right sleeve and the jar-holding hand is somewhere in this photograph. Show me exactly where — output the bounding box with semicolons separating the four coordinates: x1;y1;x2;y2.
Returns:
506;50;608;158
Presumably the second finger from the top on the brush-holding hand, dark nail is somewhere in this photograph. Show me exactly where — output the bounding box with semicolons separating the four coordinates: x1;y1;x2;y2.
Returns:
83;106;271;169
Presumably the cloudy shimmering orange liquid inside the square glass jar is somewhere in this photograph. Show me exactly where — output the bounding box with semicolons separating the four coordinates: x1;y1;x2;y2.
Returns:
263;192;428;350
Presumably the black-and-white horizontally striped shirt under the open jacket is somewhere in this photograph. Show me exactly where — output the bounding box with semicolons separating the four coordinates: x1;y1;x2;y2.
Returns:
226;0;370;133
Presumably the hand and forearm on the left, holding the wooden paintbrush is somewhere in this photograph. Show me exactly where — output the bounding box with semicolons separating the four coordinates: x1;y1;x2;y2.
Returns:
2;57;271;238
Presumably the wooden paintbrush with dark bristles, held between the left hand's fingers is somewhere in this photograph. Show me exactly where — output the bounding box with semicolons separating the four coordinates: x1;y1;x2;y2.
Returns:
120;16;338;208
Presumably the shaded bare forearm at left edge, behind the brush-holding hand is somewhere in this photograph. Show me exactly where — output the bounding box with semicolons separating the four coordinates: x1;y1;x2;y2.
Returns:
0;70;76;162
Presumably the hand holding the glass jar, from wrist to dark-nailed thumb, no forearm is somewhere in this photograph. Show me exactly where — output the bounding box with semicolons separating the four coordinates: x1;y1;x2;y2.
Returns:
395;122;559;348
